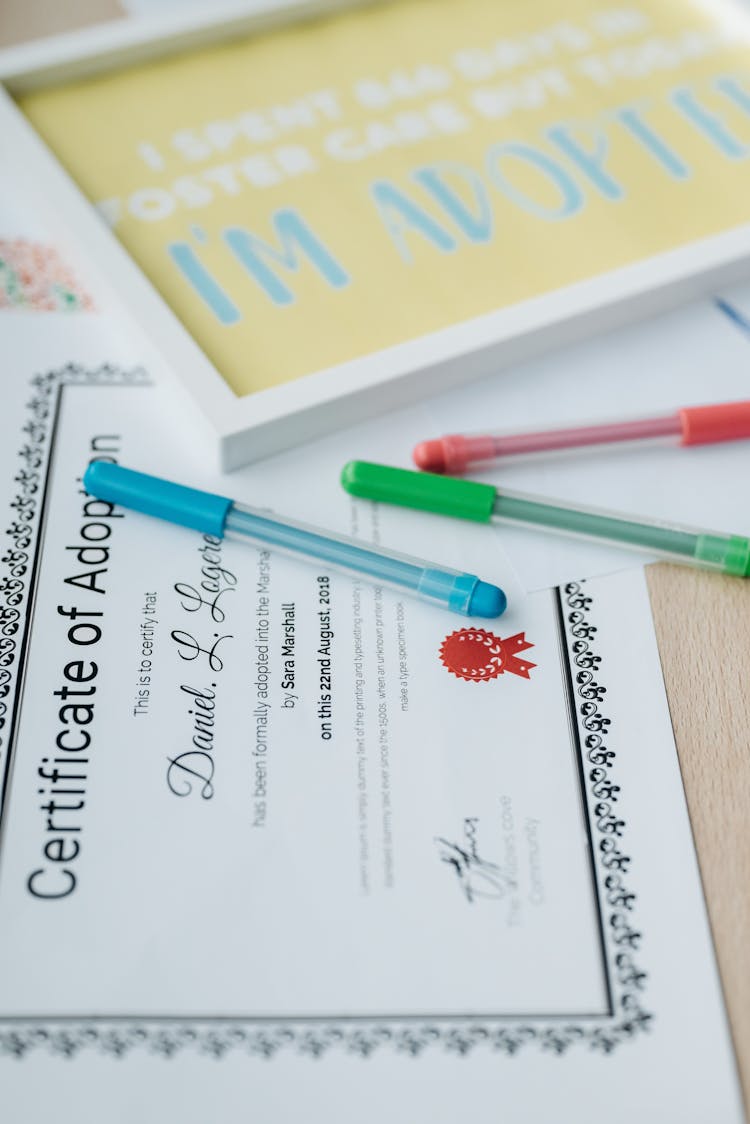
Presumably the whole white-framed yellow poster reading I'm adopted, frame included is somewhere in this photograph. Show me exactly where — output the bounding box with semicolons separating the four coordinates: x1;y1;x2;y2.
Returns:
0;0;750;468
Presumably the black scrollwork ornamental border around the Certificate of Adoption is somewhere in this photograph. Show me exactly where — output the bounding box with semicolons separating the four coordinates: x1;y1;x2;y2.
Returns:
0;365;653;1059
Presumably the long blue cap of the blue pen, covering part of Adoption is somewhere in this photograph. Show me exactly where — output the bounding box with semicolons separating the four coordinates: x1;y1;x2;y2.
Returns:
83;461;233;538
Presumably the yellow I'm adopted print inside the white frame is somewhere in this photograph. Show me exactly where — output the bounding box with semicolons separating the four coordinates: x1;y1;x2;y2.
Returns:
19;0;750;396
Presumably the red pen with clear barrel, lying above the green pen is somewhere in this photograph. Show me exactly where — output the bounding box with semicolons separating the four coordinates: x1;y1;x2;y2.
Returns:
413;401;750;475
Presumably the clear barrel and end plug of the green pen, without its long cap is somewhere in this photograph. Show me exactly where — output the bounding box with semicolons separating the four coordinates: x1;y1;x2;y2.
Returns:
491;489;750;578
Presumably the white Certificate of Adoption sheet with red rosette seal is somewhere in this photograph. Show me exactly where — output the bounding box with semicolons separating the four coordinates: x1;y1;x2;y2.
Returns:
0;328;742;1124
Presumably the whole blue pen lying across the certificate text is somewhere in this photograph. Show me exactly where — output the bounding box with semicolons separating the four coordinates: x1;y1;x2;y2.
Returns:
83;461;507;617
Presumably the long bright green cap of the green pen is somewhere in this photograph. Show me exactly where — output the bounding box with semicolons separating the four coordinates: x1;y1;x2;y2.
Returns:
341;461;497;523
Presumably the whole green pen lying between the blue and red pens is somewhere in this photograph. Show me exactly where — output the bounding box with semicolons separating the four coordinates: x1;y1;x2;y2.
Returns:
341;461;750;578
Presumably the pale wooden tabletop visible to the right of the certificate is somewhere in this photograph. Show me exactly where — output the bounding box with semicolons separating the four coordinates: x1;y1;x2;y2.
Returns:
647;563;750;1118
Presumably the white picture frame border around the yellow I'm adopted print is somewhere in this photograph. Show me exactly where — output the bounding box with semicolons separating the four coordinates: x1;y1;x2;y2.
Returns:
0;0;750;470
